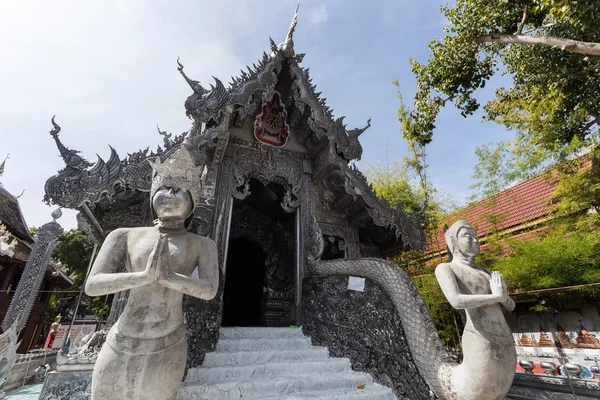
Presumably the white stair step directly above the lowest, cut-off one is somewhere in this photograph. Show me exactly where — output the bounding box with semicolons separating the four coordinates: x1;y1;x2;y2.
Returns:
179;372;373;400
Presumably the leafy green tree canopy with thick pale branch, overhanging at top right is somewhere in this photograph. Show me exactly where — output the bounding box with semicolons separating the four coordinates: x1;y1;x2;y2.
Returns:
399;0;600;156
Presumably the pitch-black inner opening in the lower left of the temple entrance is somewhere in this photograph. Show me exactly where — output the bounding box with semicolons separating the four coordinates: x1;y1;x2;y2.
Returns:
221;238;265;326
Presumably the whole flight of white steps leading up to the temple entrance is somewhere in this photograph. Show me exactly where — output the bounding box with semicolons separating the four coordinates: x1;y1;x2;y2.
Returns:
179;328;396;400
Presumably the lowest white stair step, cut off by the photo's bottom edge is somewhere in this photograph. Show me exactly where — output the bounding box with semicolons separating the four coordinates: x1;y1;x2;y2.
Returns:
245;383;397;400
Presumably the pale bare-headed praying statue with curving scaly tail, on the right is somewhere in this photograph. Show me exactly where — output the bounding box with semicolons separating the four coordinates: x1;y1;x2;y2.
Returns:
435;221;517;400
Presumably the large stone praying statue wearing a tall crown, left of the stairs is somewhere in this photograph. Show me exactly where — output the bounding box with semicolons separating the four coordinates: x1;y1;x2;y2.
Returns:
85;147;219;400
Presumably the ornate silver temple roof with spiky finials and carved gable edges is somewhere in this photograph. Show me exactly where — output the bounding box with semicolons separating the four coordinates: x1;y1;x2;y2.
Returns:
44;9;425;253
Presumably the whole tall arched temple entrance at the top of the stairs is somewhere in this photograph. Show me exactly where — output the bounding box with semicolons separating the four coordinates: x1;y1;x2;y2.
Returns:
221;180;296;326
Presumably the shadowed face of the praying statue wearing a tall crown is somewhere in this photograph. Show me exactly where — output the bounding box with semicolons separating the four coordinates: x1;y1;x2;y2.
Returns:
152;186;194;221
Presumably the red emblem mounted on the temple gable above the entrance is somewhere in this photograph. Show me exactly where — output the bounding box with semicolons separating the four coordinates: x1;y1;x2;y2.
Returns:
254;92;290;147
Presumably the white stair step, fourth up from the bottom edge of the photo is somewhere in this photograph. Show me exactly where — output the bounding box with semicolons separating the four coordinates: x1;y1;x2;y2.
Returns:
202;346;329;367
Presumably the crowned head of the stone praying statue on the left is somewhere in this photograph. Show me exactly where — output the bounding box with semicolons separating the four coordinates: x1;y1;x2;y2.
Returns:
150;147;204;221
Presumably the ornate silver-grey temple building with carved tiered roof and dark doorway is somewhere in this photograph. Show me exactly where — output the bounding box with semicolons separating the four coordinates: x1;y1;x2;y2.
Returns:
45;10;435;393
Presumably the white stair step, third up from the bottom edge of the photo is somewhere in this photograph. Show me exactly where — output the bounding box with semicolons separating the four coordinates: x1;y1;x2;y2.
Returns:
185;358;351;384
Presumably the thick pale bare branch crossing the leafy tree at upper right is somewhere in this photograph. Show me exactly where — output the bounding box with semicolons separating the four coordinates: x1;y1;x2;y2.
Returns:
475;32;600;56
